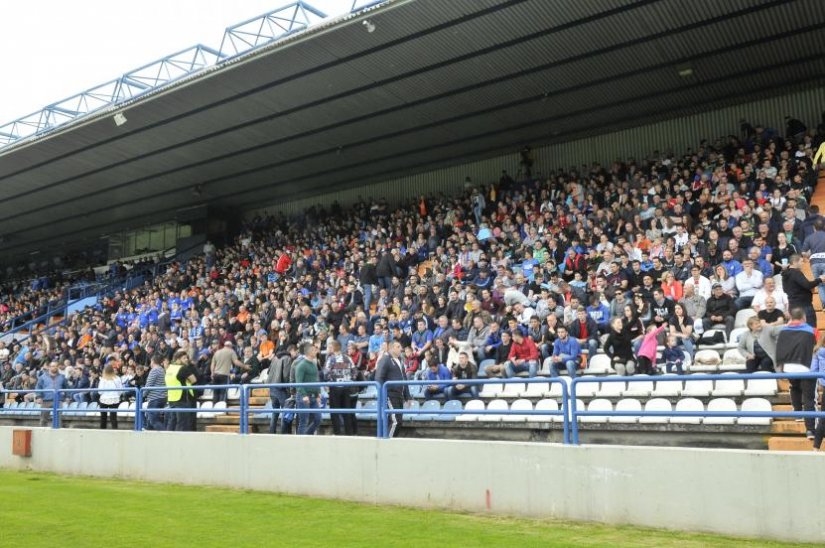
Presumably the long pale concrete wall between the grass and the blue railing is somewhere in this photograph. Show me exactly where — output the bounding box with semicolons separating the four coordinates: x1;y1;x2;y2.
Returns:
0;427;825;542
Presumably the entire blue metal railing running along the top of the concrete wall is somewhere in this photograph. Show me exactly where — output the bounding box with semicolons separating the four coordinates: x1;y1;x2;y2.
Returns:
0;373;825;445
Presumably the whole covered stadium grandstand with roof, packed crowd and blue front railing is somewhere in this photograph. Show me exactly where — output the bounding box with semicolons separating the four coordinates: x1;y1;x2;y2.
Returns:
0;0;825;540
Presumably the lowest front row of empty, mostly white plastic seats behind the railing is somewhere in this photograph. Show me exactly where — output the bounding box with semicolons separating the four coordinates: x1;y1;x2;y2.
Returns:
348;398;772;426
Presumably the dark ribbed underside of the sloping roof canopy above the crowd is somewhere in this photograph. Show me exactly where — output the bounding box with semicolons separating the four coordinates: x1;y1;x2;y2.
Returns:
0;0;825;256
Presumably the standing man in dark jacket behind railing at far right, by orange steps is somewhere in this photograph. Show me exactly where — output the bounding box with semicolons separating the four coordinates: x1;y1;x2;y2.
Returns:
776;307;816;439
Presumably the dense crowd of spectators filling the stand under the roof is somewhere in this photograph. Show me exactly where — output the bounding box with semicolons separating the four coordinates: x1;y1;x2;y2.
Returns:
0;113;825;433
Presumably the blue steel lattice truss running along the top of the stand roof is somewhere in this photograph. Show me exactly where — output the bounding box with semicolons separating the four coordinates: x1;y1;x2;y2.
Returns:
0;0;385;150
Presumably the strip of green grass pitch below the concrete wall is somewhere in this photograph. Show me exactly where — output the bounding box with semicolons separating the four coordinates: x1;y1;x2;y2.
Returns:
0;471;808;548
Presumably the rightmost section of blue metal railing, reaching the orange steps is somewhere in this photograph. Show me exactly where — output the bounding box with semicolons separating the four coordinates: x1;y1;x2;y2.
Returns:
570;373;825;445
